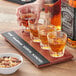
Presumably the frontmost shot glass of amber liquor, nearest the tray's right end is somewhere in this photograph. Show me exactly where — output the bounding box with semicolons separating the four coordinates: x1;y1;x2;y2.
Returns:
47;31;67;57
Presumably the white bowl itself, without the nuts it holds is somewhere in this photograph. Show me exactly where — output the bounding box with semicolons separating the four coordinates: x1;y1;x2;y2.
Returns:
0;53;23;74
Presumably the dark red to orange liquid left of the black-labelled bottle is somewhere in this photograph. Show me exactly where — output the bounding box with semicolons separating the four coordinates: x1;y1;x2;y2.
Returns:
44;0;61;30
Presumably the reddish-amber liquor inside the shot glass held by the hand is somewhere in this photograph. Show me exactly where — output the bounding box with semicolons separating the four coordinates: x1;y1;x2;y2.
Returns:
21;13;36;27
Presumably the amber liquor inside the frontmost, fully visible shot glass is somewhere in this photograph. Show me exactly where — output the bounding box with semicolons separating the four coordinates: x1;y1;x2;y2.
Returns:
49;38;66;53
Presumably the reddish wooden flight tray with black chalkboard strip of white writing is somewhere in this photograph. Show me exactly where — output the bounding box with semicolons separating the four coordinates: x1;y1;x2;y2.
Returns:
2;30;73;68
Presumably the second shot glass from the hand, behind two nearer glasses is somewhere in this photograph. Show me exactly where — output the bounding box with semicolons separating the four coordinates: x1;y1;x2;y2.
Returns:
29;19;46;42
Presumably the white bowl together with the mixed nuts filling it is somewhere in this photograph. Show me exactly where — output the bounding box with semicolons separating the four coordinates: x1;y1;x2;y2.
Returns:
0;53;23;74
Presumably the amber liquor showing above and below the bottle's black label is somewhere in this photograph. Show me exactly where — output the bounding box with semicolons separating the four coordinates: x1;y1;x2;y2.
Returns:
68;0;76;48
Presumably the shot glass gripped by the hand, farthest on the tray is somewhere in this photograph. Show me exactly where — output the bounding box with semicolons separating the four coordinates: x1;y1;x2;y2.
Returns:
19;7;36;32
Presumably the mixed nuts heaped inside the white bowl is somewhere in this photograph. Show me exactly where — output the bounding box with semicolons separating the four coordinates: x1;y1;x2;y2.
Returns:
0;56;21;68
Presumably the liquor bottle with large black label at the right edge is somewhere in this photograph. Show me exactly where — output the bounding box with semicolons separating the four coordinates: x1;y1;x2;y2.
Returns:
61;0;76;48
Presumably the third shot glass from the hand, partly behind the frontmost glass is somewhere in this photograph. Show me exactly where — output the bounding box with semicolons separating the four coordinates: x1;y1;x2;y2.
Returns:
38;25;56;50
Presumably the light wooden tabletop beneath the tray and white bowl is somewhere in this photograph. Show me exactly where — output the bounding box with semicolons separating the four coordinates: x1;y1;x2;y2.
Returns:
0;0;76;76
